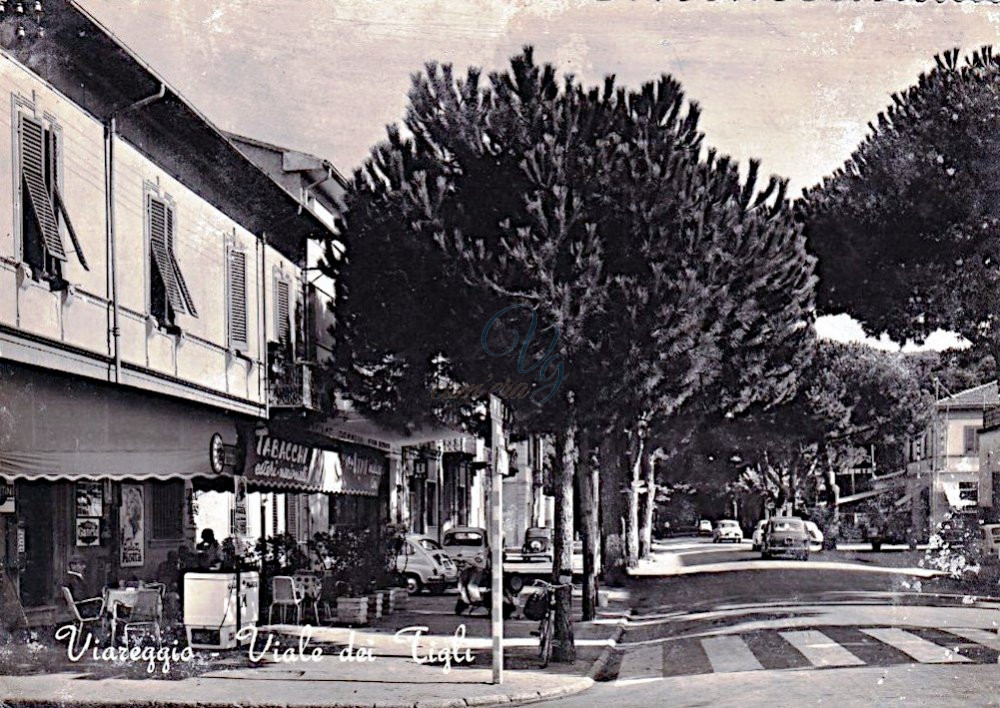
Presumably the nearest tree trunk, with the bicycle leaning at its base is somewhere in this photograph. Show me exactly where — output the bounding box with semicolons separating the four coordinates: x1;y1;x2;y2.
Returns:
552;404;577;662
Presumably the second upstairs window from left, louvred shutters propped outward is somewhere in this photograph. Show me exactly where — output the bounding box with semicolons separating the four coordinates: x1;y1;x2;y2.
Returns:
146;195;198;331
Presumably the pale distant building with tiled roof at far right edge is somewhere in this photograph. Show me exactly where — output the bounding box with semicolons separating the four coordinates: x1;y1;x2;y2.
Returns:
906;381;1000;535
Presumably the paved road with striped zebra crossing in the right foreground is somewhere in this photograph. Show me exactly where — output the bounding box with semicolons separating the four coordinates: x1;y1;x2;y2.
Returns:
546;539;1000;708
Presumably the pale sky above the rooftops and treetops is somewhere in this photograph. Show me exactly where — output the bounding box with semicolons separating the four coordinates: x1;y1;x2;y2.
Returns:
79;0;1000;348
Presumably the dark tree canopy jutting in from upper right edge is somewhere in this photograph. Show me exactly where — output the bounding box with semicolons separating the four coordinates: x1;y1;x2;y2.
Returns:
798;47;1000;360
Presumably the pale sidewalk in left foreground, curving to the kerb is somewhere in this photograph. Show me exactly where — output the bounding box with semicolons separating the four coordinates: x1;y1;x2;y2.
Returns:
0;594;627;708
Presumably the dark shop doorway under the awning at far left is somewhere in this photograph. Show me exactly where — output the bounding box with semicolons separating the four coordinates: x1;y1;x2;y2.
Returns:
17;482;55;607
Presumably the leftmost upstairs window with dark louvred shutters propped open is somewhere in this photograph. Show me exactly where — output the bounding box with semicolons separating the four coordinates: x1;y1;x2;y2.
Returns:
17;112;89;287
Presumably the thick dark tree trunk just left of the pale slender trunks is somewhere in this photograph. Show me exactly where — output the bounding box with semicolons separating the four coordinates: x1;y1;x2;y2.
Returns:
600;430;628;587
